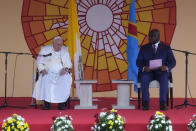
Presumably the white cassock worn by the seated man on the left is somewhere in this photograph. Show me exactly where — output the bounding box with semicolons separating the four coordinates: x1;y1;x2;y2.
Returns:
33;45;72;103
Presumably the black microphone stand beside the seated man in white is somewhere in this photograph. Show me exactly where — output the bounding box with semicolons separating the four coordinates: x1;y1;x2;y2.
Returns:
0;52;31;109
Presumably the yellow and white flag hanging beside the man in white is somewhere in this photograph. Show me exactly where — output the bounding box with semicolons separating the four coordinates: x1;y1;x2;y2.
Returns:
67;0;83;97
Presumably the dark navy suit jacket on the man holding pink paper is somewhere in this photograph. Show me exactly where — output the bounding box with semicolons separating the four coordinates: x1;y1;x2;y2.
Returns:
137;42;176;71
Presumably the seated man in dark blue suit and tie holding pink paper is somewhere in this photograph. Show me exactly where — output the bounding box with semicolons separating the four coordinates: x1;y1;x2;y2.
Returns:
137;29;176;110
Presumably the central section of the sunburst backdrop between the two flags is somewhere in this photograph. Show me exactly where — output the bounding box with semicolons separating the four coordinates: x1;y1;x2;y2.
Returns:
78;0;129;91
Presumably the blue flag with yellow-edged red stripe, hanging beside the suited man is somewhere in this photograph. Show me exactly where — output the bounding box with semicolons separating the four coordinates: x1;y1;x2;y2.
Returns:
127;0;139;92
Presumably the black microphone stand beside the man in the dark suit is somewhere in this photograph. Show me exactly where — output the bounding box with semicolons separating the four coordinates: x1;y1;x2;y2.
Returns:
172;49;196;109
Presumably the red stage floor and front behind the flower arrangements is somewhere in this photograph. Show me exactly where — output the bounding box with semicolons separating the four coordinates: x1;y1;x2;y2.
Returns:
0;98;196;131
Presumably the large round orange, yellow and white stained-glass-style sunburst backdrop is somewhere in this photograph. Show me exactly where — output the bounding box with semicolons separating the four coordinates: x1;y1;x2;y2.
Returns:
22;0;176;91
